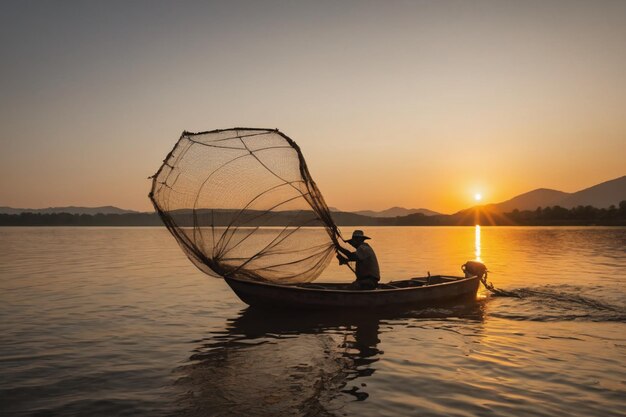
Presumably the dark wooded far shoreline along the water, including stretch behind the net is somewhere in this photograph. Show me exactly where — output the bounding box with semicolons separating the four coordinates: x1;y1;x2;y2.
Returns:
0;201;626;227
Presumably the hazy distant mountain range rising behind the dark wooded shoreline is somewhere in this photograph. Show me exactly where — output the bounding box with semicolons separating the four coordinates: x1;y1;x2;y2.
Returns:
0;175;626;216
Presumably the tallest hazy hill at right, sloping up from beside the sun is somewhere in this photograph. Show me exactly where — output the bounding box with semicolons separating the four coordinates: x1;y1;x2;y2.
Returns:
486;175;626;213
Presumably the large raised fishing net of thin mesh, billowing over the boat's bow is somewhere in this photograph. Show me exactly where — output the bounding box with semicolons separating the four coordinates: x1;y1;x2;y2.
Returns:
149;128;341;283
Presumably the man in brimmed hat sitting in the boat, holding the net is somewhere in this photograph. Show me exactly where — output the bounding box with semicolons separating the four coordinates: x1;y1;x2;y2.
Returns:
337;230;380;290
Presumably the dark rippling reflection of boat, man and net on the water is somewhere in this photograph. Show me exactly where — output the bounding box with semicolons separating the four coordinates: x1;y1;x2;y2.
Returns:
177;301;483;415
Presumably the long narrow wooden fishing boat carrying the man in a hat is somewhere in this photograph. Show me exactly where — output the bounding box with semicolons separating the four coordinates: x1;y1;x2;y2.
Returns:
224;264;486;310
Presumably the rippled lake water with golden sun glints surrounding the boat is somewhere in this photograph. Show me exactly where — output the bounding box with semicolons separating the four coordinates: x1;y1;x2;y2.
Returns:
0;227;626;416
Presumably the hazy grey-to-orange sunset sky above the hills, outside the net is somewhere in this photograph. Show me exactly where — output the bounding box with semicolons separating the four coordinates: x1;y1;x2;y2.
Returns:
0;0;626;212
